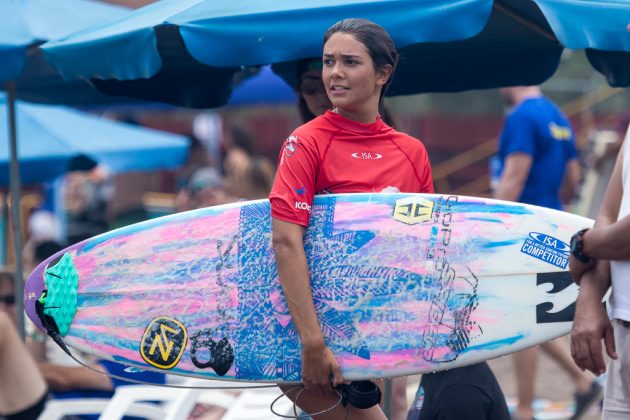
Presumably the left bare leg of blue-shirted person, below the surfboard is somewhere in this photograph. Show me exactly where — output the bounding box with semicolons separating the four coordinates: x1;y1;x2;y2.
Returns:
513;347;538;420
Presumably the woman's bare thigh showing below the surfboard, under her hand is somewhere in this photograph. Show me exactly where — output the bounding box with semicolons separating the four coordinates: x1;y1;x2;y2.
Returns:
280;385;387;420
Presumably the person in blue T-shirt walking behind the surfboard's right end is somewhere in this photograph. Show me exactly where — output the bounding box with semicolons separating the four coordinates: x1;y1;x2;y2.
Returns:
491;86;602;419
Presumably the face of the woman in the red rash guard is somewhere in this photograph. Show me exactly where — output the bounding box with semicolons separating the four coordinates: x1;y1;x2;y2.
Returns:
322;32;389;112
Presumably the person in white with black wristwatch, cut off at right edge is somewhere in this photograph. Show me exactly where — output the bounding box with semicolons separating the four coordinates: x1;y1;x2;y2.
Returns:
569;123;630;420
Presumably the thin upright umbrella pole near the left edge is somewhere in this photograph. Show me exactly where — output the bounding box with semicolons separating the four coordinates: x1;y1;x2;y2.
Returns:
7;81;25;341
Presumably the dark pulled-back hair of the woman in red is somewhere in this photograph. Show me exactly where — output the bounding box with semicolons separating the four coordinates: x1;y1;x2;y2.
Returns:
324;18;398;98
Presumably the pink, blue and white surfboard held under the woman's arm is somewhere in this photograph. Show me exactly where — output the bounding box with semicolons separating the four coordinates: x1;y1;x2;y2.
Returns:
24;194;593;383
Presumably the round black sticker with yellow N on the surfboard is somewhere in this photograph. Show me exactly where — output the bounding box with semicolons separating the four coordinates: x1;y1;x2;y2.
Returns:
140;316;188;369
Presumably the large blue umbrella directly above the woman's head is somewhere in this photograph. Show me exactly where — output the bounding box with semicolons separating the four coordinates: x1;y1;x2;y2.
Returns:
43;0;492;107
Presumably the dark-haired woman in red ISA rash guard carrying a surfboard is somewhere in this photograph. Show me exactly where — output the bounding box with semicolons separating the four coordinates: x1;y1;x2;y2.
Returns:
270;19;433;420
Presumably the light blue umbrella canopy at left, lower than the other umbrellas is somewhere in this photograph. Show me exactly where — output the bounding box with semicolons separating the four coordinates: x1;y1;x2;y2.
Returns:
0;95;188;186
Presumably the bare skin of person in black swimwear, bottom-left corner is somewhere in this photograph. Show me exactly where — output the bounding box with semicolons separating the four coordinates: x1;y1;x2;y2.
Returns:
0;312;46;414
